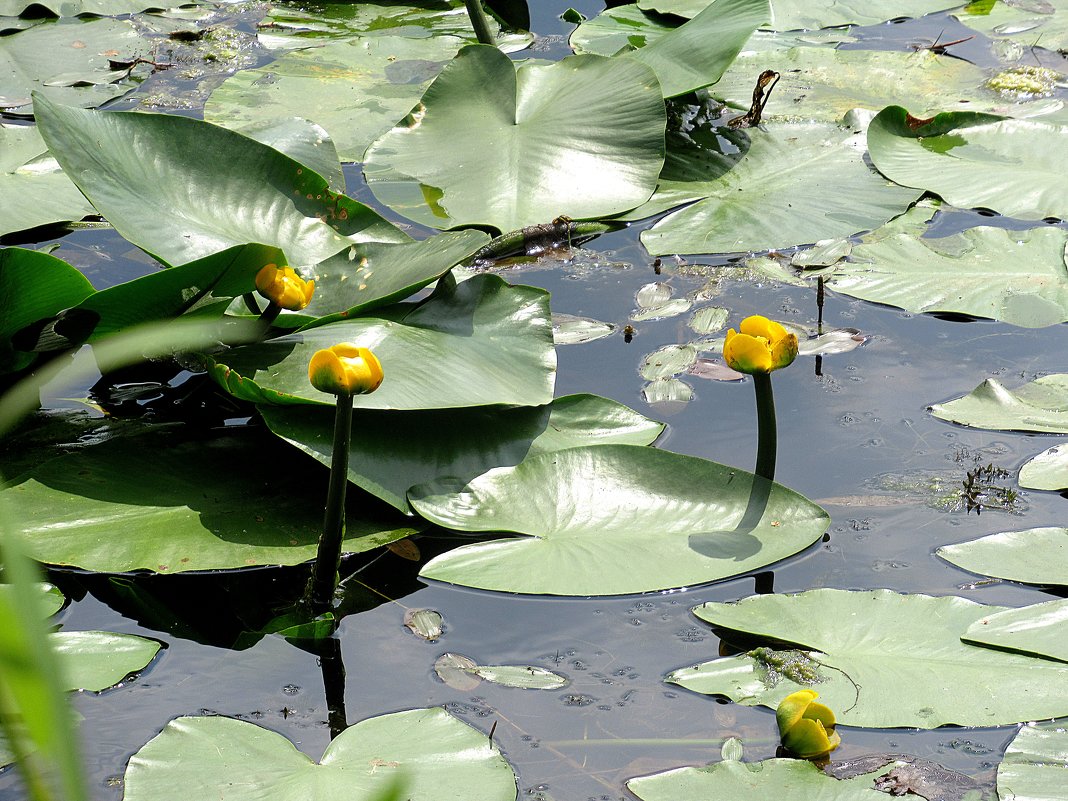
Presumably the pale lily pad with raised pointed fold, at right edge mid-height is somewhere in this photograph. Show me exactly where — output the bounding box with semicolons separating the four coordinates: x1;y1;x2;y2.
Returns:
930;373;1068;434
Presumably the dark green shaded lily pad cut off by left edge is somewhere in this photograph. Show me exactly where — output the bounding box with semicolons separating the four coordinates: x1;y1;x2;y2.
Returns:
0;248;93;373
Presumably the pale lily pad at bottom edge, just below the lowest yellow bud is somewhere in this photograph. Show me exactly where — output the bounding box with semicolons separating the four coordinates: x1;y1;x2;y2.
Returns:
627;759;886;801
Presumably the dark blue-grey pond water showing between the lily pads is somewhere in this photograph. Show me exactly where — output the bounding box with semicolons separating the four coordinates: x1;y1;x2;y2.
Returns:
0;0;1068;801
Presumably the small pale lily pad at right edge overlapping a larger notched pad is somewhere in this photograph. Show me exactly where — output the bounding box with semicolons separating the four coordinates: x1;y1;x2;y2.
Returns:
960;600;1068;662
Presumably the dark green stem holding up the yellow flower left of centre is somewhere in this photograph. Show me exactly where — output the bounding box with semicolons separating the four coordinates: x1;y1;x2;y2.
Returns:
308;395;352;614
